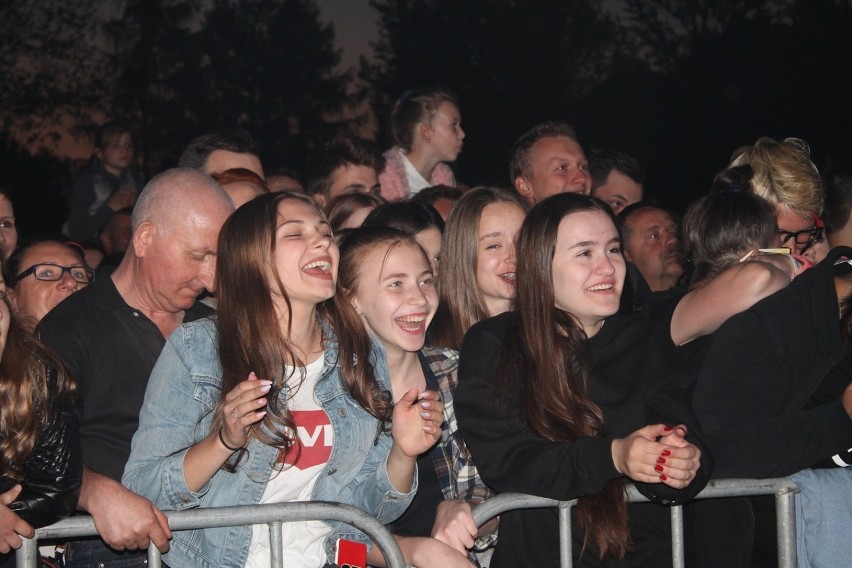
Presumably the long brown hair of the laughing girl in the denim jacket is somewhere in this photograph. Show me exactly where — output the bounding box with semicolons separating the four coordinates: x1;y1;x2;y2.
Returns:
216;191;390;471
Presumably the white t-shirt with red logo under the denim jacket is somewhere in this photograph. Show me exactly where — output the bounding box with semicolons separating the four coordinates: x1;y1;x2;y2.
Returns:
245;355;333;568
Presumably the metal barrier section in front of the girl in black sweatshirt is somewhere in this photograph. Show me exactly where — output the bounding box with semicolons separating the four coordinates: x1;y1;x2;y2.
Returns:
473;477;799;568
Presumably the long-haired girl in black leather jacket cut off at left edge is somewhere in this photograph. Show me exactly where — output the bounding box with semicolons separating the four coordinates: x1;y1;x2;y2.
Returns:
0;270;83;566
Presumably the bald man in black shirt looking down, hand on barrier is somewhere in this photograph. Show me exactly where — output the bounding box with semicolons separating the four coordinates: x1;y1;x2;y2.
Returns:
39;168;234;566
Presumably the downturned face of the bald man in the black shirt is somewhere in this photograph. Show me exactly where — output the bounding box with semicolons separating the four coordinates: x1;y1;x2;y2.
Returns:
140;200;233;313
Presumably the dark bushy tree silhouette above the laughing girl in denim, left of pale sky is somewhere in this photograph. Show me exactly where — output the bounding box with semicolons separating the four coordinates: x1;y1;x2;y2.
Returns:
193;0;361;172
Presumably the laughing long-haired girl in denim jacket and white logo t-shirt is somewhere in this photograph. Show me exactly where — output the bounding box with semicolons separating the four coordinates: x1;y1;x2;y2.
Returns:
122;192;441;568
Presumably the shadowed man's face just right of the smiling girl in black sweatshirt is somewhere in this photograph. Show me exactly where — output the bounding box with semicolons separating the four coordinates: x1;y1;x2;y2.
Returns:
624;207;683;292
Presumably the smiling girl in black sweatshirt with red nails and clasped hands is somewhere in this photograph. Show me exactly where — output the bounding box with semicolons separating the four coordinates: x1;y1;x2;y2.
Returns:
455;194;710;568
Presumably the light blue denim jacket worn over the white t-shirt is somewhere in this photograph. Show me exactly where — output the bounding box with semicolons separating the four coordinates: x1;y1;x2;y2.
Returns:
122;319;417;568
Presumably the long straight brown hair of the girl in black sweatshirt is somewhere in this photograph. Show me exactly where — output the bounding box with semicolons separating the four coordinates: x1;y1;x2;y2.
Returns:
498;193;630;559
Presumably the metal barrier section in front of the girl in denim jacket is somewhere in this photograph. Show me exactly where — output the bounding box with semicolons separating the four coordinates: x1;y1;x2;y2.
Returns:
16;501;405;568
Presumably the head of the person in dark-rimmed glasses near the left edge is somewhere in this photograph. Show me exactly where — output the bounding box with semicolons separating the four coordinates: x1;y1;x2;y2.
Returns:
6;240;95;330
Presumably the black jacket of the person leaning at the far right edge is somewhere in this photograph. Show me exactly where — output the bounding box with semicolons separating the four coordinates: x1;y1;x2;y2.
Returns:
693;247;852;478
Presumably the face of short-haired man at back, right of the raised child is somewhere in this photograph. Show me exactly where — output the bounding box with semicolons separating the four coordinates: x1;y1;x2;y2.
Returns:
515;136;592;205
